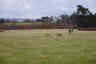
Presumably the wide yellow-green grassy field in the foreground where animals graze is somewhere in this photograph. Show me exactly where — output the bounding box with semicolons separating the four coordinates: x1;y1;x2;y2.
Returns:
0;29;96;64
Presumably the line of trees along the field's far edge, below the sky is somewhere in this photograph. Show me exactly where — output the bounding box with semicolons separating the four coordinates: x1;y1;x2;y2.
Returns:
0;5;96;28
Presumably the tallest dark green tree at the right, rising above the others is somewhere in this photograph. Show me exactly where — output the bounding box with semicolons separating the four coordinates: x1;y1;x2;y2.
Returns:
71;5;96;28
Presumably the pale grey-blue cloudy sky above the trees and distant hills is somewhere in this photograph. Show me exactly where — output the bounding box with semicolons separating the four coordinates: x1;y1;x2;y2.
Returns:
0;0;96;19
